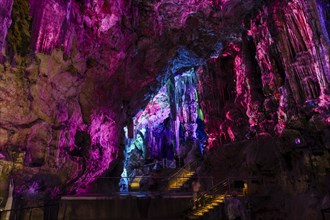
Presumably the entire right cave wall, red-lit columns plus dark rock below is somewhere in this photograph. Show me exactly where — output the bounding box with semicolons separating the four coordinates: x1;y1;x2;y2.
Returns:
199;1;330;219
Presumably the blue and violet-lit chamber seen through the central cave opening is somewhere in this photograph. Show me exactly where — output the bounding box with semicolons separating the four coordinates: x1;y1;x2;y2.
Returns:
120;60;207;191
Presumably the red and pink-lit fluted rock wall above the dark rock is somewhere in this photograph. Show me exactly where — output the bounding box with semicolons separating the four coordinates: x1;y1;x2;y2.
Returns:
200;1;329;146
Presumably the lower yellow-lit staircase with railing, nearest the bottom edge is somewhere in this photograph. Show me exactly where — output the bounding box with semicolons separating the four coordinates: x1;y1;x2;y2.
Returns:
185;178;247;219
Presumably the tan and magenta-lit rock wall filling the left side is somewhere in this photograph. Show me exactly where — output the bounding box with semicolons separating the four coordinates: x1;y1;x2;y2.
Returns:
0;1;139;205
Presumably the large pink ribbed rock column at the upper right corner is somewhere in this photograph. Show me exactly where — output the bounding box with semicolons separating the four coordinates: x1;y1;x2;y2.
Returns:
273;1;329;106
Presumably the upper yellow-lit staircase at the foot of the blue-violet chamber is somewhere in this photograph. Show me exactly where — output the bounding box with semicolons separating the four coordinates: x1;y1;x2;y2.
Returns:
166;160;200;191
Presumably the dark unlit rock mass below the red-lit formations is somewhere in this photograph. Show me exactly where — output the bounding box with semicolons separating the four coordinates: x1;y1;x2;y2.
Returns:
200;137;330;219
